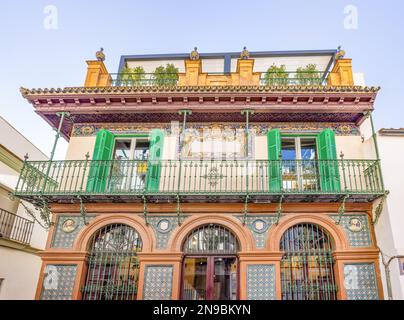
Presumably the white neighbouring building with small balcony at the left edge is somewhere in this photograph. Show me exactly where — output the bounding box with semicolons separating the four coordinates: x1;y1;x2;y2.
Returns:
0;117;47;300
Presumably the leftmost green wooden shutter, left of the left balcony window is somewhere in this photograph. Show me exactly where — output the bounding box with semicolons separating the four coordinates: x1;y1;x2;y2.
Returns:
87;129;114;192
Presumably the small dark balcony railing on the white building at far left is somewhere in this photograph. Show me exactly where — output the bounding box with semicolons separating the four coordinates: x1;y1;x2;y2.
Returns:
0;209;34;244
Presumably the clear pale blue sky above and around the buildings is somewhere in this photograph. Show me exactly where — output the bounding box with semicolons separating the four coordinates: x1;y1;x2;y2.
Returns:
0;0;404;159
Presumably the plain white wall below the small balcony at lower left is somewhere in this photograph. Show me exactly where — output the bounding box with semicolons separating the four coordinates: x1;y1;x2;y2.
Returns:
0;247;41;300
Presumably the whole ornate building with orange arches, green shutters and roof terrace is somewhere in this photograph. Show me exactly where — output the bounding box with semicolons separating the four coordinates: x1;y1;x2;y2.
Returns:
15;49;385;300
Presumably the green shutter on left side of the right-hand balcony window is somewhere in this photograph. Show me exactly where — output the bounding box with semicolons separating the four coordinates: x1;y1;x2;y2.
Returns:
267;129;282;192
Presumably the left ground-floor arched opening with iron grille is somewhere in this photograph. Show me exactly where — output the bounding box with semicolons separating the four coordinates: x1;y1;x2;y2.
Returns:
83;224;142;300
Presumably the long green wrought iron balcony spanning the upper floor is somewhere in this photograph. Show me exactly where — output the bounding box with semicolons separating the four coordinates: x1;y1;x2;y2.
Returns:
15;160;384;202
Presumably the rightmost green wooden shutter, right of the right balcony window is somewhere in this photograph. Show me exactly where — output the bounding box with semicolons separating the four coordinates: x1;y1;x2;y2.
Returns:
317;129;341;192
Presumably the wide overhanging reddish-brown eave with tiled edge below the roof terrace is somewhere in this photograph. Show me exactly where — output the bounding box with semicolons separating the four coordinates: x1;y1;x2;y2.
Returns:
21;86;380;139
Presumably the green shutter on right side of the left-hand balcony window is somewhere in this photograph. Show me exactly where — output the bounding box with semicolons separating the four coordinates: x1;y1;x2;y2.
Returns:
146;129;164;192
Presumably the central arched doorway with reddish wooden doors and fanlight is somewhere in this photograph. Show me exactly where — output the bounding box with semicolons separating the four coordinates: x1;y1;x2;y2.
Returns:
182;224;239;300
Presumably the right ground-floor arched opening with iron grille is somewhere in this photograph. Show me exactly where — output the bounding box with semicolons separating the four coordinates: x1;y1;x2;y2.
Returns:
280;223;337;300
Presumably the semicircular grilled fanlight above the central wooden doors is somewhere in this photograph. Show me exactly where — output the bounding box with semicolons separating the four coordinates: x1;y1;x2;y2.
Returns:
183;224;238;255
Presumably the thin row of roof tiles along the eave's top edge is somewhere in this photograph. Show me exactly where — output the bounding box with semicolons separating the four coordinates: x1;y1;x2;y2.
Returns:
20;85;380;98
